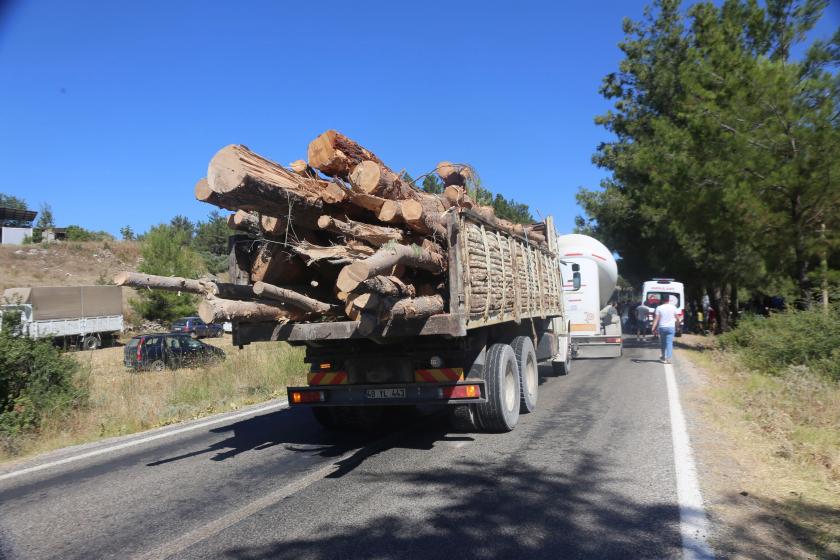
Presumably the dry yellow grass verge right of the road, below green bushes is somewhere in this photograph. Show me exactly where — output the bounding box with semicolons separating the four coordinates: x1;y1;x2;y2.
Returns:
681;336;840;557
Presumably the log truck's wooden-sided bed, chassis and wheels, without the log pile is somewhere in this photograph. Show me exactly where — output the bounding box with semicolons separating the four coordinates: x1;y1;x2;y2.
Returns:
230;210;571;432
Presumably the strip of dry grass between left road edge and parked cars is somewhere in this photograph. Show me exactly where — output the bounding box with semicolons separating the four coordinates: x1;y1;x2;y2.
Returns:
0;338;306;459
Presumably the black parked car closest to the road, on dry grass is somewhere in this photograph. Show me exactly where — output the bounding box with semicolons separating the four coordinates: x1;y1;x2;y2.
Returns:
123;333;225;371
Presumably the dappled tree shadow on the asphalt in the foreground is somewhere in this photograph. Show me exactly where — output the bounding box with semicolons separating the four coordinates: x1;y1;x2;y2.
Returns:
210;453;680;560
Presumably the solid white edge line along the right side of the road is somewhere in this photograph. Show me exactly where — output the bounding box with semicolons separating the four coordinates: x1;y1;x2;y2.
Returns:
665;364;715;560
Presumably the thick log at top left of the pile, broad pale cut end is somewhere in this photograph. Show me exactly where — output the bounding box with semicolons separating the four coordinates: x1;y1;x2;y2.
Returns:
207;145;342;219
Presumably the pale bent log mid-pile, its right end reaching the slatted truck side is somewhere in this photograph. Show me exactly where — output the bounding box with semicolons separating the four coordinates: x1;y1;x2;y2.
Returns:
336;243;446;292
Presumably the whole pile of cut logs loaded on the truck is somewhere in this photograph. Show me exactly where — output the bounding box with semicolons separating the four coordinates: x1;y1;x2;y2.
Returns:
115;130;545;331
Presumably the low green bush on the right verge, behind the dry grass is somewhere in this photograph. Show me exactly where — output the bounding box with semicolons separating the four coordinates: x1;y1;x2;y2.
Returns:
719;306;840;381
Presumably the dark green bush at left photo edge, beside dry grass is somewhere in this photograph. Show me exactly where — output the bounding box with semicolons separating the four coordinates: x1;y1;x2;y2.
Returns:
0;313;87;440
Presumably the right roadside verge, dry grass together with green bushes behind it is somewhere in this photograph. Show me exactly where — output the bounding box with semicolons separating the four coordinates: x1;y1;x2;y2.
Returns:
683;307;840;557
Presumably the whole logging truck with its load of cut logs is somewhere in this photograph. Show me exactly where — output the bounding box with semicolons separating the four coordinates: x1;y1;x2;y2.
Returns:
114;130;580;432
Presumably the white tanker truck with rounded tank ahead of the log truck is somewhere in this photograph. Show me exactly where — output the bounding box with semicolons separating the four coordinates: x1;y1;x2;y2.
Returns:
557;233;621;358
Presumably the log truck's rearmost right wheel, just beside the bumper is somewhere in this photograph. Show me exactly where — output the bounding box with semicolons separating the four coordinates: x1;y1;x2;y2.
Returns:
475;344;520;432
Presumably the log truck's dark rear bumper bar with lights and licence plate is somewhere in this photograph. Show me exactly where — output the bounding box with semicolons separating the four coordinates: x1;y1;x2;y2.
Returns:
287;379;487;407
